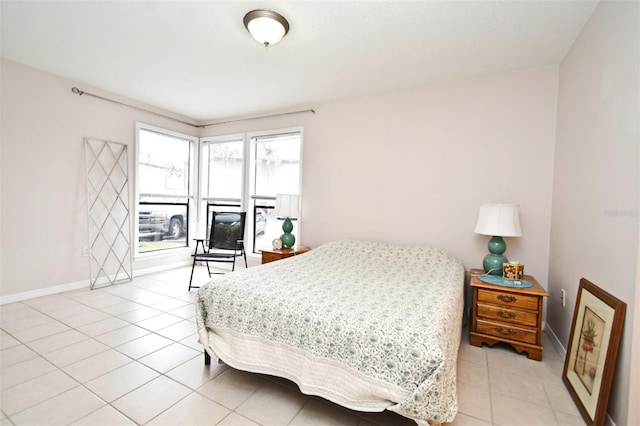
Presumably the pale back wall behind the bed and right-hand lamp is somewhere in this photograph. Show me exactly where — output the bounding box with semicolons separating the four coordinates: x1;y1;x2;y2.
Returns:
205;66;557;280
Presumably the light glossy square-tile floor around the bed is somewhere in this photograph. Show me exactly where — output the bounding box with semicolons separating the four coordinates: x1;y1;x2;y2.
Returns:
0;268;584;426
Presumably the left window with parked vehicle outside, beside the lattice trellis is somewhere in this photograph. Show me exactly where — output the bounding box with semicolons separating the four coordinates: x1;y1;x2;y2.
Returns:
136;123;197;253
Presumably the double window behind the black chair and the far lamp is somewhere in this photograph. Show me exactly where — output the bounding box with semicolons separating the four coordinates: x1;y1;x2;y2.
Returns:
200;130;302;252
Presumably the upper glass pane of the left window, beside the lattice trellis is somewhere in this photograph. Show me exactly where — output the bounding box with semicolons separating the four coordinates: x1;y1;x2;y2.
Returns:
138;129;190;198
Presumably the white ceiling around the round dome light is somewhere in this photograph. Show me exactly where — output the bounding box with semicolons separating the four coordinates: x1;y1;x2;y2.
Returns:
0;0;597;121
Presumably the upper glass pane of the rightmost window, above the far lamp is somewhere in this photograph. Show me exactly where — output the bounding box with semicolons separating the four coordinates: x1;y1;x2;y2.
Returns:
254;133;300;197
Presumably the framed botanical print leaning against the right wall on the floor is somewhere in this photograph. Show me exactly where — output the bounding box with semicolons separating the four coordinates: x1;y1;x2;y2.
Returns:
562;278;627;425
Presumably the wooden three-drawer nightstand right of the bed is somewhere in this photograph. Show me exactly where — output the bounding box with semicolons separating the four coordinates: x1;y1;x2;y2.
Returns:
469;270;549;361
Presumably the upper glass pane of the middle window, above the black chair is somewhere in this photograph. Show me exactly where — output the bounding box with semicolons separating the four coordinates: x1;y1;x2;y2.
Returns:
203;139;243;200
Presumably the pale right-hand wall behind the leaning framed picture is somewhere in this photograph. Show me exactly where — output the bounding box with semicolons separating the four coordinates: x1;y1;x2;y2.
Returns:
547;1;640;425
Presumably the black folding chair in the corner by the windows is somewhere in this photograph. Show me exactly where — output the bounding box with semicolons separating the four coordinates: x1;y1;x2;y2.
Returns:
189;211;247;291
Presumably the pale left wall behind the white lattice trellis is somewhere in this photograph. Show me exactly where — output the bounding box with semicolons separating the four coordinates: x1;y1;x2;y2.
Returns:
0;59;198;301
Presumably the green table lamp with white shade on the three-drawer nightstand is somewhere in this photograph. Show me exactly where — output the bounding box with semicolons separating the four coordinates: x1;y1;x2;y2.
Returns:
474;204;522;275
